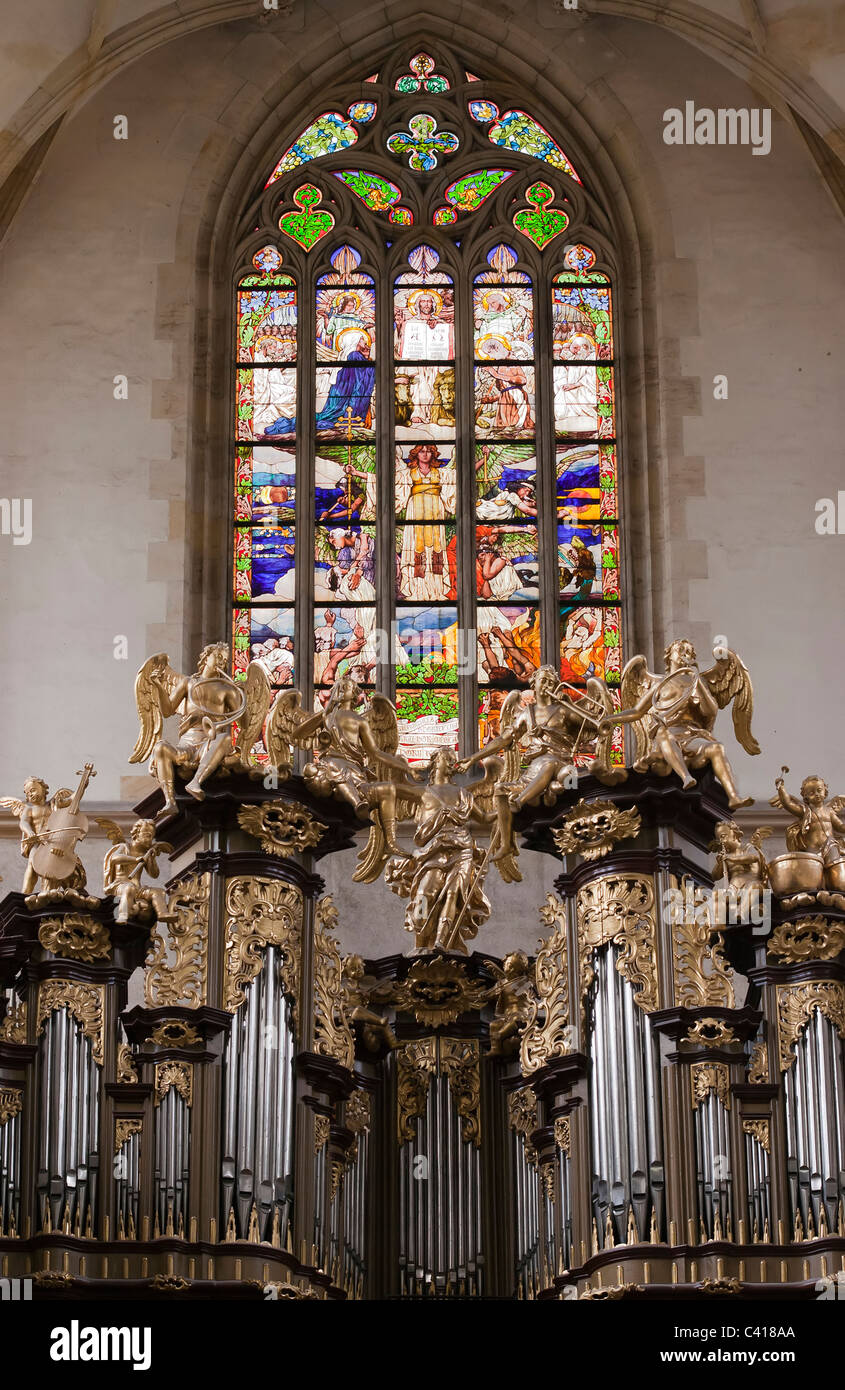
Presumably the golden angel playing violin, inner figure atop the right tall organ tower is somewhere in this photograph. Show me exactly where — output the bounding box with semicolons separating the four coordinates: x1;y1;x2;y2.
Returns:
472;666;628;810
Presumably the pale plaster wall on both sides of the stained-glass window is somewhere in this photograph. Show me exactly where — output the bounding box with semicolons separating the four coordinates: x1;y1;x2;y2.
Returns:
0;6;845;949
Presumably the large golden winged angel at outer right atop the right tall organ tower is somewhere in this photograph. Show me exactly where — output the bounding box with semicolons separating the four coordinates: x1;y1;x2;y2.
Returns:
599;639;760;810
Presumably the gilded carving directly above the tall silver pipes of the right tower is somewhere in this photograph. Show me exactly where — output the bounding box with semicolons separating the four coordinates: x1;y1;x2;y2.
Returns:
575;874;657;1019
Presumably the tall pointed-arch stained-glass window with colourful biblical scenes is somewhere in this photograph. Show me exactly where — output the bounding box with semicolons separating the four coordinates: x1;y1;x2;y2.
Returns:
233;44;621;760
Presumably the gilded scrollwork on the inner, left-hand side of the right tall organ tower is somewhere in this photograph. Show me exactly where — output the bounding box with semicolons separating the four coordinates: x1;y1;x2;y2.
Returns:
520;892;573;1076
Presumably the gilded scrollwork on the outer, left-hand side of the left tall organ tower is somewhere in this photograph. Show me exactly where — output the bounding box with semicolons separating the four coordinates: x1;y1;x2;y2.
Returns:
145;873;211;1009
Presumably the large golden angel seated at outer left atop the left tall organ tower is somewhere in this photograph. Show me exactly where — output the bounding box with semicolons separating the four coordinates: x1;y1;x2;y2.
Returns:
129;642;271;821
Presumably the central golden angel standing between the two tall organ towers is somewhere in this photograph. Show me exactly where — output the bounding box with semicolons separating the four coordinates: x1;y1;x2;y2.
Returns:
354;748;521;955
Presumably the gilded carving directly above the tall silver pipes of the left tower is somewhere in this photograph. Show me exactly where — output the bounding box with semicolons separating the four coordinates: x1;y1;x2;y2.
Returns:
222;874;303;1017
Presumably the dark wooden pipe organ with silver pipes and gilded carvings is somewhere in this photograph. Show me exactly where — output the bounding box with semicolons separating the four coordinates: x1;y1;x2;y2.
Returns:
0;774;845;1301
